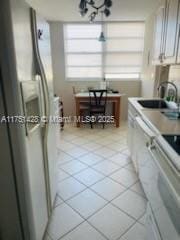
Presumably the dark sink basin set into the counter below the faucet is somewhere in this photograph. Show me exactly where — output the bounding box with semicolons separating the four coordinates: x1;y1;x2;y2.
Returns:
138;99;168;109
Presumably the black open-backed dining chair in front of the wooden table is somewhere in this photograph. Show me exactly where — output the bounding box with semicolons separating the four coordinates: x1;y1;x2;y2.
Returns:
89;89;107;128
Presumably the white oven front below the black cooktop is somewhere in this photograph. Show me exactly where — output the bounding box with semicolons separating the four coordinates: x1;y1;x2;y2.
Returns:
147;140;180;240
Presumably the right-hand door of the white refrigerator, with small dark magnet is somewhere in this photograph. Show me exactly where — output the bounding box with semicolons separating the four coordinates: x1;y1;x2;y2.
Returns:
31;9;57;215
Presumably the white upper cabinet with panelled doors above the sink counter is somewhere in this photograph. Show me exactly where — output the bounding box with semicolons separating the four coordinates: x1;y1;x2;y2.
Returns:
153;0;180;65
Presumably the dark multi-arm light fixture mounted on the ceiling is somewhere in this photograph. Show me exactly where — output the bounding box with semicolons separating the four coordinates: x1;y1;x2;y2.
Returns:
79;0;112;22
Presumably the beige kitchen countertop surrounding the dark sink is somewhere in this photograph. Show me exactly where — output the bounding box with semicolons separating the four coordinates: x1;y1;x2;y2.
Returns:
129;98;180;135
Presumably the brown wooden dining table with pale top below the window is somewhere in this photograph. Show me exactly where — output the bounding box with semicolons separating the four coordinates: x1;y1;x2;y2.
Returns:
75;92;124;128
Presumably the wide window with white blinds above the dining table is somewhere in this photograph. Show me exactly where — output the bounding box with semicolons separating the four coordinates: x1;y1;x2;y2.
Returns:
64;22;144;80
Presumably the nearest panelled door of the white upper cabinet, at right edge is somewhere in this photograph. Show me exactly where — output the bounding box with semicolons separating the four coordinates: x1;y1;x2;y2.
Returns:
164;0;179;64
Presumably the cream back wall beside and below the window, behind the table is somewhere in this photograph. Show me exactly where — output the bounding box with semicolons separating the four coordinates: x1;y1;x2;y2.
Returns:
50;22;141;120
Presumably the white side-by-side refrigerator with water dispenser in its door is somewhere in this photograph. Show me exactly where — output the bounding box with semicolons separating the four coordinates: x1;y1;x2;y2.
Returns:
0;0;60;240
